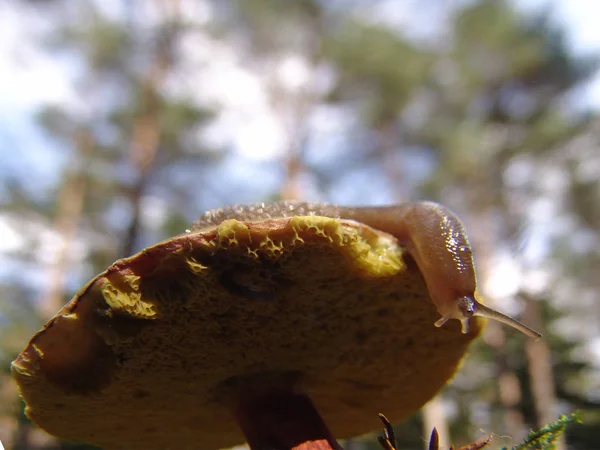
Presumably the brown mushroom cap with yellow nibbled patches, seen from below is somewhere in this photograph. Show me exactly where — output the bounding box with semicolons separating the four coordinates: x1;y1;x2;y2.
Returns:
12;216;484;450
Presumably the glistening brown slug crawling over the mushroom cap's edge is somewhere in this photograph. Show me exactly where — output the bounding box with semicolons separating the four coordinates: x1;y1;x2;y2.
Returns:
192;201;542;340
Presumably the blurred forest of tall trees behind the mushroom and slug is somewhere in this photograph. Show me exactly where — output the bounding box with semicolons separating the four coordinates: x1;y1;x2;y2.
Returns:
0;0;600;450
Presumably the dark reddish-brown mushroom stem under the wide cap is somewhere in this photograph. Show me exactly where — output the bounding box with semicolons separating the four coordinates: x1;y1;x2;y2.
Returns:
234;391;342;450
